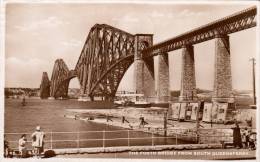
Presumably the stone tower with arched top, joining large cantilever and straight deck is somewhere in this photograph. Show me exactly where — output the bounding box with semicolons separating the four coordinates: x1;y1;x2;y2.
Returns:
134;34;155;99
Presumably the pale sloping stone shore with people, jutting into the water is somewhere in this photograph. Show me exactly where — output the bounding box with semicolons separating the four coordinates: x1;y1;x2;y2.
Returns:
65;107;252;143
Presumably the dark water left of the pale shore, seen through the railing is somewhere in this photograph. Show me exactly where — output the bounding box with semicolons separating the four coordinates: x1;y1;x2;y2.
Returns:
4;99;189;148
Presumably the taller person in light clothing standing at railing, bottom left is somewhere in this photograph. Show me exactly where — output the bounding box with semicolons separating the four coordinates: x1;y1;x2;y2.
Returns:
32;126;45;158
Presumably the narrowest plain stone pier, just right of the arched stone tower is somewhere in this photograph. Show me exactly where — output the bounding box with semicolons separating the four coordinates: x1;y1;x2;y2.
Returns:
156;53;169;103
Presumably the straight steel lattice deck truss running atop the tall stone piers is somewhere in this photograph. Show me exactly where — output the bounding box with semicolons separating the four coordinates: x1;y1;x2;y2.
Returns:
142;7;257;58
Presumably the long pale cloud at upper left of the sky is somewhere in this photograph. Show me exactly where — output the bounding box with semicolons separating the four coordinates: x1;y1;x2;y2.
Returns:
14;16;69;31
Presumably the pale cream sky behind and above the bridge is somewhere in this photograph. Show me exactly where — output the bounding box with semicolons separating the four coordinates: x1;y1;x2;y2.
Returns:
5;3;256;90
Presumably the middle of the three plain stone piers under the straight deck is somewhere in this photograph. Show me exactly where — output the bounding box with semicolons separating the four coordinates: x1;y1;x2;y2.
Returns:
179;45;197;102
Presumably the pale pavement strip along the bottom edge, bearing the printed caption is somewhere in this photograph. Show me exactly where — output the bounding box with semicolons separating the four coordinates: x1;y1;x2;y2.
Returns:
56;149;256;160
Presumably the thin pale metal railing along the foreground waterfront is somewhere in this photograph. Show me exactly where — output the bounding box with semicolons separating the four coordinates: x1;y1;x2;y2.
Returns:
5;128;256;149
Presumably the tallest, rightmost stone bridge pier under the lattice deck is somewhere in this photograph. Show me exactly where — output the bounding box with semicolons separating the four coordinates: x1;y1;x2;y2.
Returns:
212;34;234;103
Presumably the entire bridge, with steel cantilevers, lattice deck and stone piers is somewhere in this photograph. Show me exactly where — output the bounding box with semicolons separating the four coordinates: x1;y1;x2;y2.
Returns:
40;6;257;102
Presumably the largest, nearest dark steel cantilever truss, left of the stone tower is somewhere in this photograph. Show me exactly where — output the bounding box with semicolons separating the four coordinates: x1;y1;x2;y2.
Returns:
75;24;135;98
